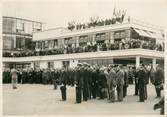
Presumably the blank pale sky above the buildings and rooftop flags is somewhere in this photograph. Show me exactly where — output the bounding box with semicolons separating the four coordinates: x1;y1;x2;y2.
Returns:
2;0;167;29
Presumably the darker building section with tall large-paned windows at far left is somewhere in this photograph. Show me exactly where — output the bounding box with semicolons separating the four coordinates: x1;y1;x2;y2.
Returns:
2;16;43;67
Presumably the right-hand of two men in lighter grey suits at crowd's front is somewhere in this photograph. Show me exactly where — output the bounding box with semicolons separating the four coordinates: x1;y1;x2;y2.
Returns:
116;65;124;101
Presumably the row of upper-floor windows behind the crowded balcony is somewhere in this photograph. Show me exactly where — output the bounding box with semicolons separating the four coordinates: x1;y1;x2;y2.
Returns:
36;30;130;49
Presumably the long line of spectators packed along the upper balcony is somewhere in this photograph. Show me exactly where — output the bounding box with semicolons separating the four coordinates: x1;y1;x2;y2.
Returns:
3;39;164;57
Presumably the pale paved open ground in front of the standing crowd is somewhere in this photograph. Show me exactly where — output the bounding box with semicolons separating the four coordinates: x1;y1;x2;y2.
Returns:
3;84;162;115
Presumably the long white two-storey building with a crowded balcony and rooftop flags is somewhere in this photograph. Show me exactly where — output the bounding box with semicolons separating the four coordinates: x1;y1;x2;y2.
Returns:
3;16;165;69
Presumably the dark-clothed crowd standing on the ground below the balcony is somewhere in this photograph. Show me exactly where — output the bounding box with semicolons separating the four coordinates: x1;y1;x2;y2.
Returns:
3;63;164;103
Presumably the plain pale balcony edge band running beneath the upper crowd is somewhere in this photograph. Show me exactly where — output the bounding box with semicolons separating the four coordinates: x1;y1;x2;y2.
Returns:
2;48;164;62
